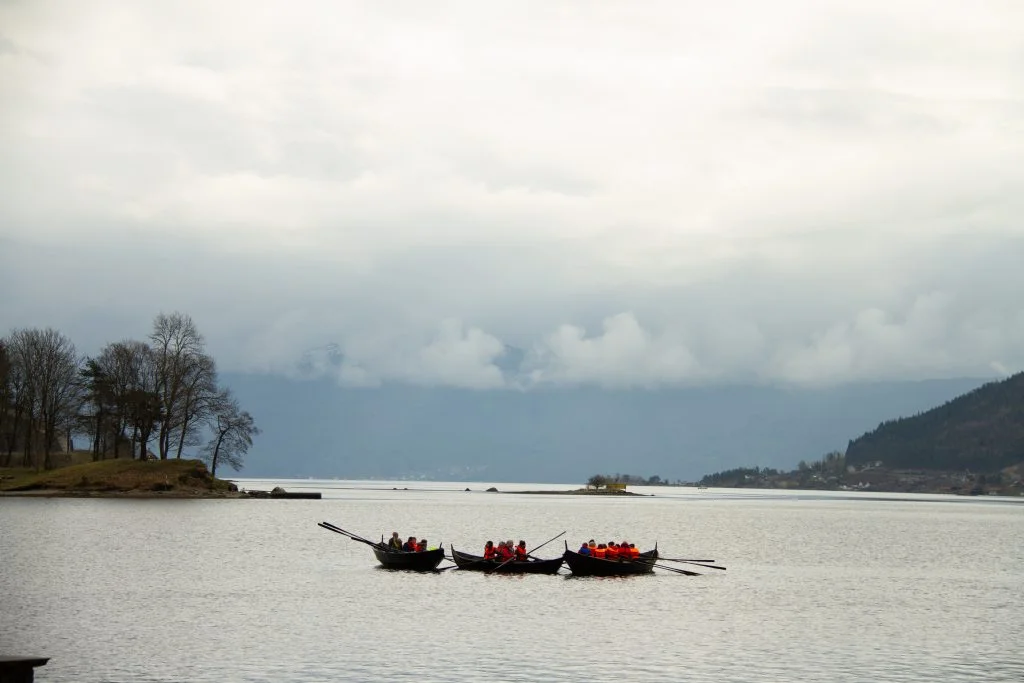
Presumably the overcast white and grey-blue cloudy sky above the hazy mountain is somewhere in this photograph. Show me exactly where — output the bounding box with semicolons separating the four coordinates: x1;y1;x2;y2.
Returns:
0;0;1024;388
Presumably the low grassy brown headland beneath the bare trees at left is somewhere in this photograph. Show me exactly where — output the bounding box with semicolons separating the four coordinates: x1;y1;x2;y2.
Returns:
0;460;240;498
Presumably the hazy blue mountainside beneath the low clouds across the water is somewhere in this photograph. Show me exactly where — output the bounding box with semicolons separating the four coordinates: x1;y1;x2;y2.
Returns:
223;374;985;483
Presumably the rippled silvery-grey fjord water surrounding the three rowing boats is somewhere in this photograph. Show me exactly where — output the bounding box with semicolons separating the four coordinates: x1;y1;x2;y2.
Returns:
0;481;1024;683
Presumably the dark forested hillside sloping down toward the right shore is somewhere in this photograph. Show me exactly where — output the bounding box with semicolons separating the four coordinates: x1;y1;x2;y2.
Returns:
846;373;1024;472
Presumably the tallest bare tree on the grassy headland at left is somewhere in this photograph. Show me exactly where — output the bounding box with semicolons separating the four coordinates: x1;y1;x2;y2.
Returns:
150;312;205;460
